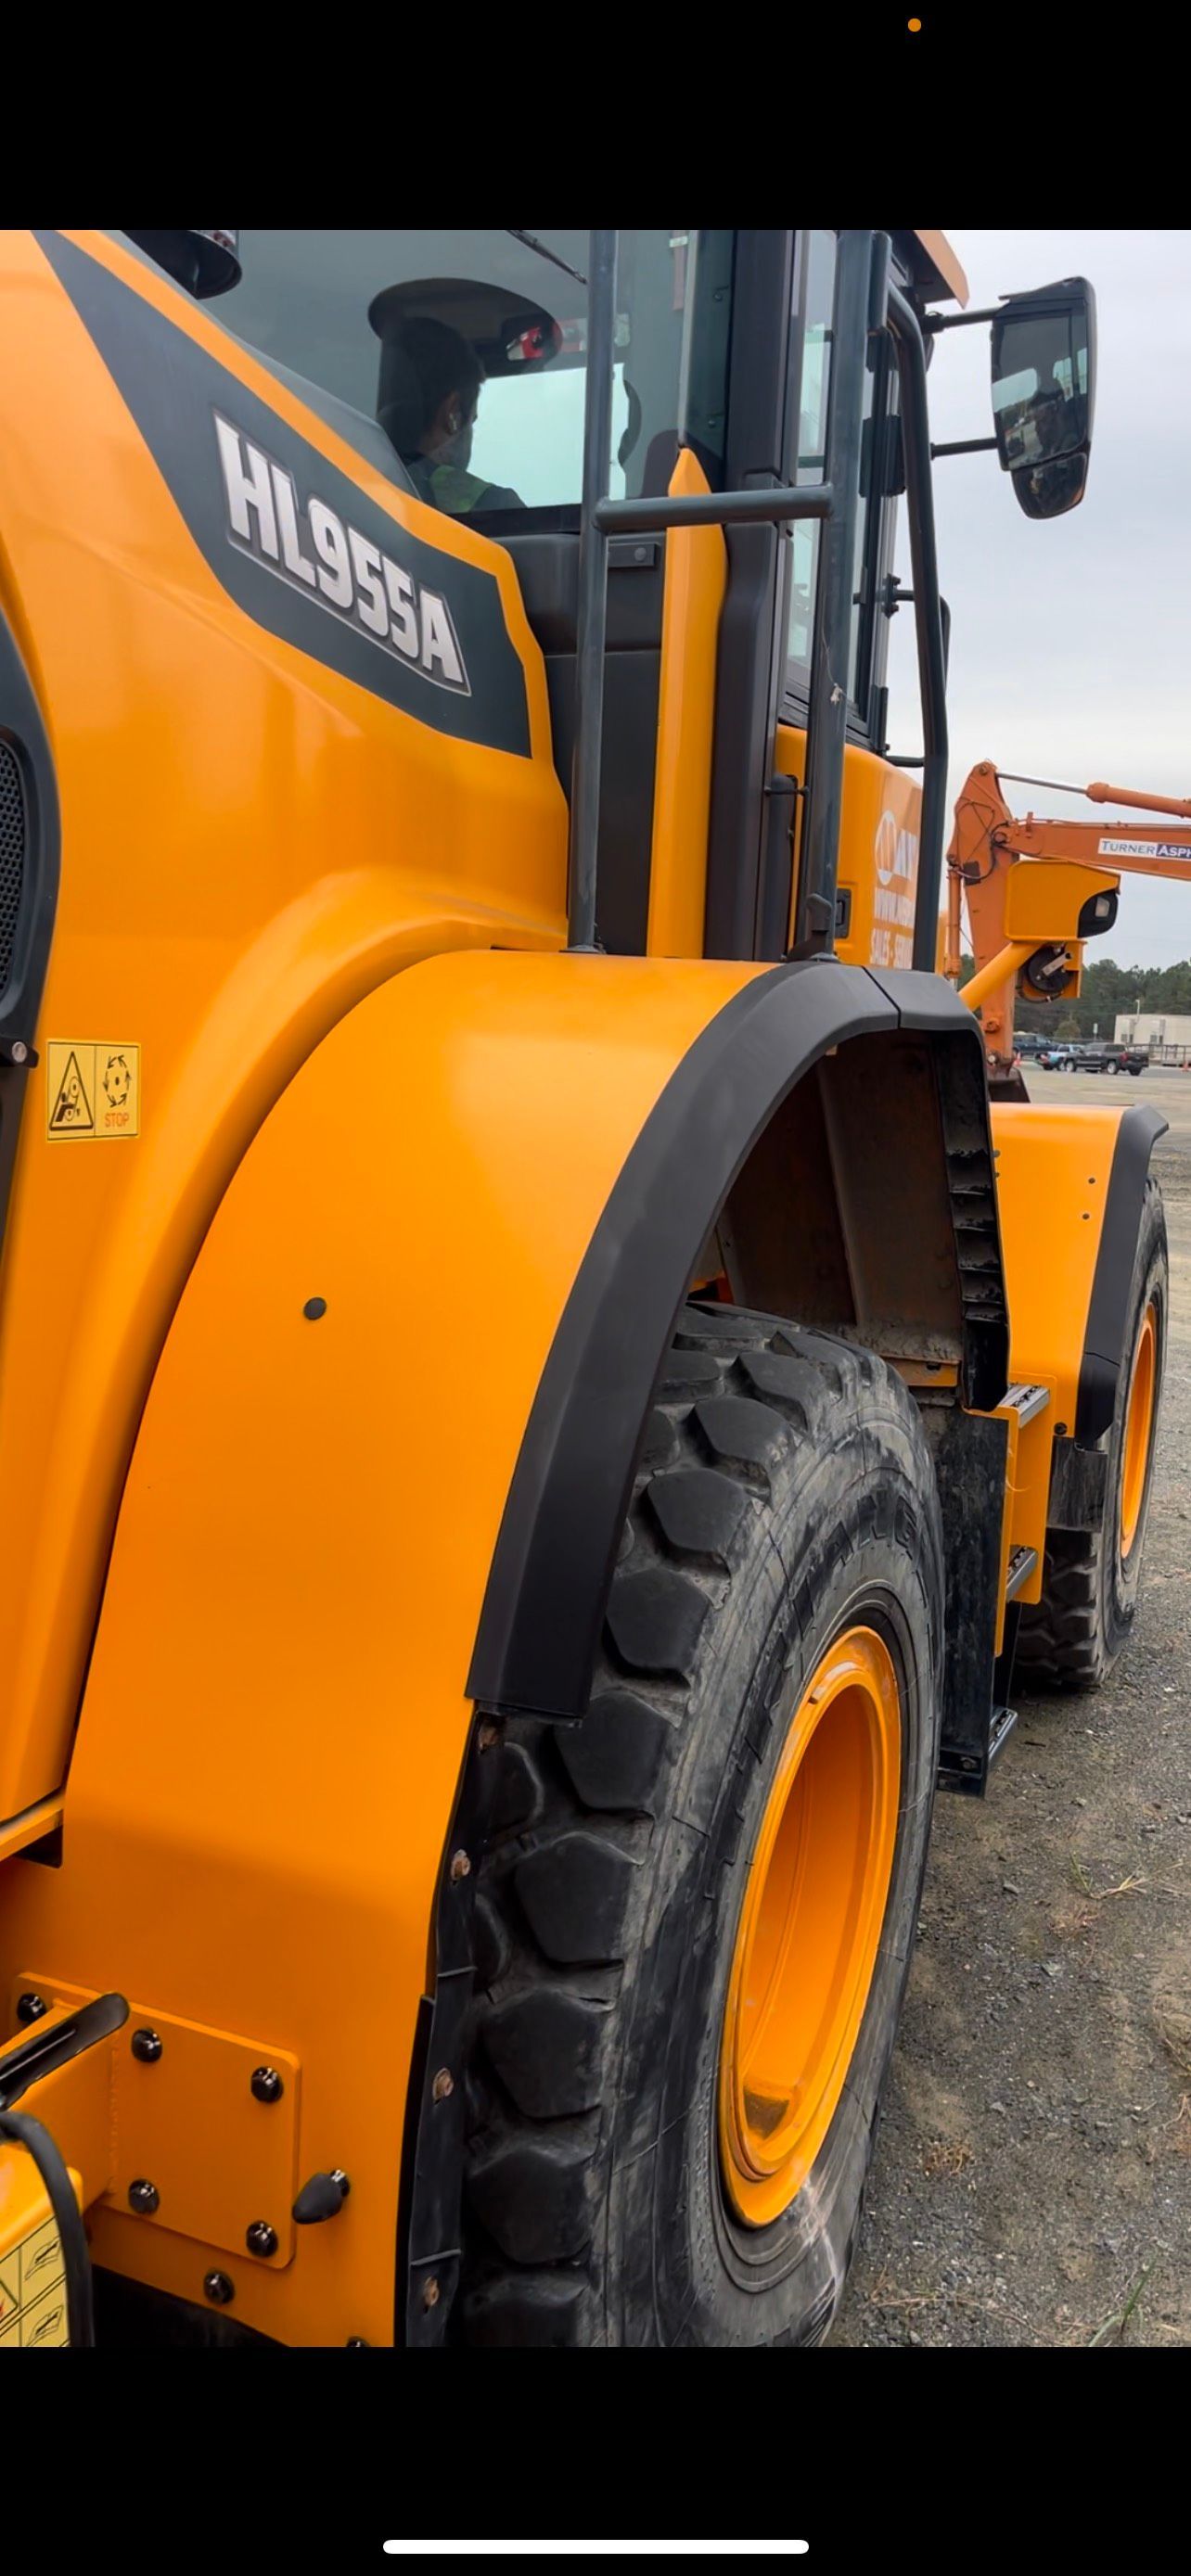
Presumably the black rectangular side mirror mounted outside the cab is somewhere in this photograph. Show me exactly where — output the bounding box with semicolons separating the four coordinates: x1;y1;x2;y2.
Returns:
992;278;1095;517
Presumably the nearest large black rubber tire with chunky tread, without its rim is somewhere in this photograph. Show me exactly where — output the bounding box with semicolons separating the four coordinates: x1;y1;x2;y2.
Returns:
464;1306;943;2344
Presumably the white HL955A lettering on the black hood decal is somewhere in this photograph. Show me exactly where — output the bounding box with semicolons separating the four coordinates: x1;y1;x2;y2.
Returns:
214;412;472;695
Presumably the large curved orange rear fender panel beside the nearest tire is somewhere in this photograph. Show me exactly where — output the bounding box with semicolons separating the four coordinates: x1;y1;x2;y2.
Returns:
0;956;758;2341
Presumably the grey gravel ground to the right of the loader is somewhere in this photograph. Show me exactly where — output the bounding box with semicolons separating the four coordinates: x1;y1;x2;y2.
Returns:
833;1072;1191;2344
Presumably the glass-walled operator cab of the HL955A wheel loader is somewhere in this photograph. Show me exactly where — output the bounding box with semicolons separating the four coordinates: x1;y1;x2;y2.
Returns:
160;229;928;966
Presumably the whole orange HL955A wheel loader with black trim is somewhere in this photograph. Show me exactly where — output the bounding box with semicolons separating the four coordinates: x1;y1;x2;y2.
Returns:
0;232;1168;2347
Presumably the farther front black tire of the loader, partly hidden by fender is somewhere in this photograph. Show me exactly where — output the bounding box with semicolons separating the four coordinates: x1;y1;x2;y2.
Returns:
1016;1180;1171;1690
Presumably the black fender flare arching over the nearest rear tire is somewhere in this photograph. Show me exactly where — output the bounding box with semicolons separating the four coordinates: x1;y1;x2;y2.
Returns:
467;958;1008;1721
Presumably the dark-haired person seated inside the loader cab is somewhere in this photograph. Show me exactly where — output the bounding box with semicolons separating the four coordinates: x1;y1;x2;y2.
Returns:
377;314;523;517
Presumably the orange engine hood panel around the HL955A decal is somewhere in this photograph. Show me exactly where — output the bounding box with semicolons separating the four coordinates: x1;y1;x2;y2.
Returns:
0;232;567;1839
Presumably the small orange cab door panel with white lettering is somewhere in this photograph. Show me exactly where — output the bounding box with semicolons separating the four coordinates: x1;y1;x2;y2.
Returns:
776;724;923;966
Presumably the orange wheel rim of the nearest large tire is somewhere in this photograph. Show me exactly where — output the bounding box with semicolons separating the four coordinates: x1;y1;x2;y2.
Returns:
719;1628;903;2228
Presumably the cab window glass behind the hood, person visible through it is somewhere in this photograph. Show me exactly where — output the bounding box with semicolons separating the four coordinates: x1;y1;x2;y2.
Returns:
161;232;732;517
